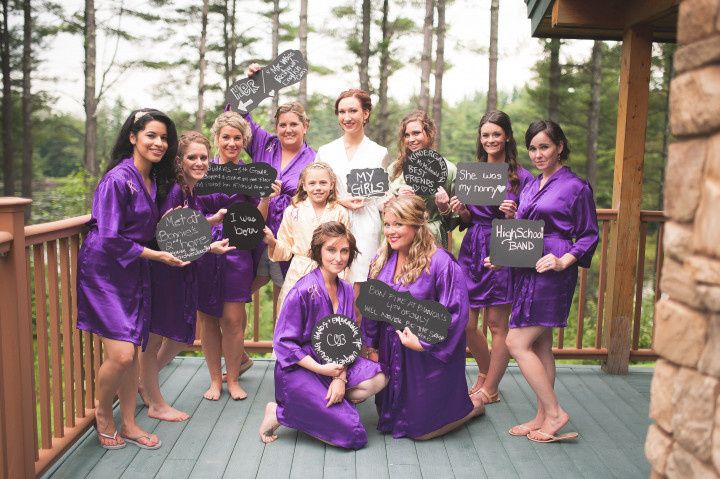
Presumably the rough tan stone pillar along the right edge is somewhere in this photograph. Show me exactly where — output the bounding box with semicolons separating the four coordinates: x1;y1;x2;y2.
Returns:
645;0;720;479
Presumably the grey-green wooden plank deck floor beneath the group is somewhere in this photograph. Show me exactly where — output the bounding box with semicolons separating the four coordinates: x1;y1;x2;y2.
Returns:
45;358;652;479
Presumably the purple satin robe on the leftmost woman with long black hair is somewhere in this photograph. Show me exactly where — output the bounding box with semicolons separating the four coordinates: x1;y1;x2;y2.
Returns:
77;158;160;345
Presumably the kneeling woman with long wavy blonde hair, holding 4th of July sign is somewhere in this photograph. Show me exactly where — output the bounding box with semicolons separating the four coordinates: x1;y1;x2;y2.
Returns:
362;196;485;440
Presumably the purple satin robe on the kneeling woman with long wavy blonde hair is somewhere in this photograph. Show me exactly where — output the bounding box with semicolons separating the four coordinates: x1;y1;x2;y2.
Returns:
362;248;473;438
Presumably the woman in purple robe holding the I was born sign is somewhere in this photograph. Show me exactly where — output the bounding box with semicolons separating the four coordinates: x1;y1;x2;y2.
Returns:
140;131;235;421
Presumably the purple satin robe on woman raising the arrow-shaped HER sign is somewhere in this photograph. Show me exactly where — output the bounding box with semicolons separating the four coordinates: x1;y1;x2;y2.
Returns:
245;113;316;276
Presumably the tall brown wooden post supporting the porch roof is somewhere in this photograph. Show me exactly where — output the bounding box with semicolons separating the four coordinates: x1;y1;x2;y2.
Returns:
603;26;652;374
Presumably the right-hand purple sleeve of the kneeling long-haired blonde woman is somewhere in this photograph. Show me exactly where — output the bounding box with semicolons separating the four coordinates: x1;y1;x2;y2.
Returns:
420;255;470;363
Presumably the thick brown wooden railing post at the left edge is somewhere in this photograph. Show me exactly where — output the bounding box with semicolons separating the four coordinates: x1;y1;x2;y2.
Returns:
0;197;36;478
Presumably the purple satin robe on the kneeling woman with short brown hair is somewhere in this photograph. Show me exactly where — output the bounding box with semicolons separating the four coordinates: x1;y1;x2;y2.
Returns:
274;268;382;449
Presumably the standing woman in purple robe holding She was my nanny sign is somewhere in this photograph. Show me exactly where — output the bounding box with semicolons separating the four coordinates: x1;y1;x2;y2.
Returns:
450;111;533;404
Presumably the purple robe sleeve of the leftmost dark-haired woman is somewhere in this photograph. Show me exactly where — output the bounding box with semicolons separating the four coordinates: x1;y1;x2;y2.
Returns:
92;177;145;268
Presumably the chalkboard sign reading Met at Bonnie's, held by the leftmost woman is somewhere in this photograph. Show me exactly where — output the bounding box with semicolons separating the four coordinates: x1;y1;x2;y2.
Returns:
155;208;212;261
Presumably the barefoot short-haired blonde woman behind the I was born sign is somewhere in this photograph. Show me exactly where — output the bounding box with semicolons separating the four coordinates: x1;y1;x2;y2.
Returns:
198;111;280;401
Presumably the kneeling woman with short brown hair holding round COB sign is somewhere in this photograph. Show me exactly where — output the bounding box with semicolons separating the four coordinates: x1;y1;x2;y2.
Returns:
260;221;387;449
